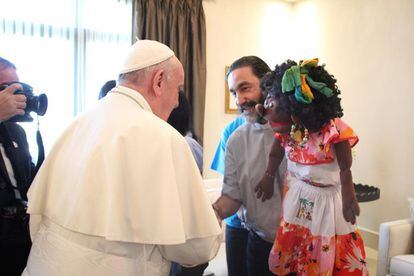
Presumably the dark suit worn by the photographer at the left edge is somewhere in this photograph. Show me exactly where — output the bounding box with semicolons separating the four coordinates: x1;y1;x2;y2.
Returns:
0;123;34;276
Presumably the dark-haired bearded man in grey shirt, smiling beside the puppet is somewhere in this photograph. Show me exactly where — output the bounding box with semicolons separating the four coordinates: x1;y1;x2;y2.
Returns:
213;56;286;276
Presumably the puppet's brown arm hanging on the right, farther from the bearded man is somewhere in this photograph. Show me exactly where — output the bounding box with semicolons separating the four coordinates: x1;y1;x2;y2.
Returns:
335;141;359;224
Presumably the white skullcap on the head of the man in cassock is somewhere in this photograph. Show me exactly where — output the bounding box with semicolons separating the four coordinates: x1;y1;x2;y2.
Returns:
119;40;174;74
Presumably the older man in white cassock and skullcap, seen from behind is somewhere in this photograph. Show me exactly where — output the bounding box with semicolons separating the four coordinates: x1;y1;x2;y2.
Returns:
22;40;221;276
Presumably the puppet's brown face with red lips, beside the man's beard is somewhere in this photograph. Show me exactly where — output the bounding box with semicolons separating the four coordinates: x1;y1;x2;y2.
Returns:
258;94;292;133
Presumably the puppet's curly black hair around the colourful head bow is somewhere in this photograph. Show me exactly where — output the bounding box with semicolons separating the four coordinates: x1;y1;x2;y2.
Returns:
260;60;343;132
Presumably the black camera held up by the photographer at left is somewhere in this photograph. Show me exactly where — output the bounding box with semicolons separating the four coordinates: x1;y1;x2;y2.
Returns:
0;82;47;122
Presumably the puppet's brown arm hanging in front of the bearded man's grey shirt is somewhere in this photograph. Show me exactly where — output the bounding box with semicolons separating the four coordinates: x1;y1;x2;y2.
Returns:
254;139;285;201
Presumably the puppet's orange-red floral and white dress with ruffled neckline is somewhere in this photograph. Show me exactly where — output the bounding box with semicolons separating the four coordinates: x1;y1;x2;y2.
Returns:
269;119;368;275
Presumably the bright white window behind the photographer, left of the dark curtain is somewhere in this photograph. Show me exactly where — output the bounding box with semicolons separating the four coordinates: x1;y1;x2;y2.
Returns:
0;0;133;156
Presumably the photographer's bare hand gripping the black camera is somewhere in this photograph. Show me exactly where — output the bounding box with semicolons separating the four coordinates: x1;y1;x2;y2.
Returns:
0;83;26;121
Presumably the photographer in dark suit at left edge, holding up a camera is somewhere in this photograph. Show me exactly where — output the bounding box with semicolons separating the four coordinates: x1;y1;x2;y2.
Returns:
0;57;34;275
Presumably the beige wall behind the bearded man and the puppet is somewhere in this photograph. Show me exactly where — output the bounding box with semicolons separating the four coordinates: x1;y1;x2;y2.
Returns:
204;0;414;235
